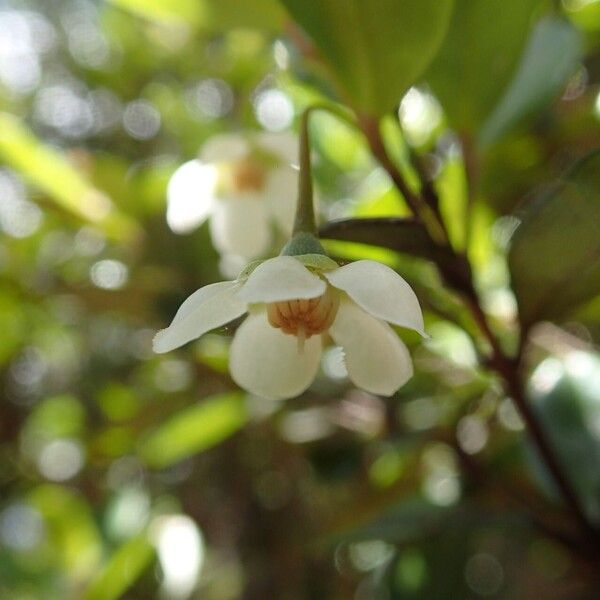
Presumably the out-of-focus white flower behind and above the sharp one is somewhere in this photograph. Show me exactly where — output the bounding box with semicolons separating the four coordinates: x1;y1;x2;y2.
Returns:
167;133;298;261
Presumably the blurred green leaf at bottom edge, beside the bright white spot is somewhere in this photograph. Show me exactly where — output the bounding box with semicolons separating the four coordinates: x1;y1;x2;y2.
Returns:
83;534;154;600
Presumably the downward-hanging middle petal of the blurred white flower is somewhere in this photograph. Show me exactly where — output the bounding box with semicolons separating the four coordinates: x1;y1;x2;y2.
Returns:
210;194;271;260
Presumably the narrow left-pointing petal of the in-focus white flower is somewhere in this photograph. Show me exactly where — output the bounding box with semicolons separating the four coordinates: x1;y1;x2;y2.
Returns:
153;281;247;354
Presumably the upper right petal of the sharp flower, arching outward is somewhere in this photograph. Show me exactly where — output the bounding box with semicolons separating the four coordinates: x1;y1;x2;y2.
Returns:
324;260;427;336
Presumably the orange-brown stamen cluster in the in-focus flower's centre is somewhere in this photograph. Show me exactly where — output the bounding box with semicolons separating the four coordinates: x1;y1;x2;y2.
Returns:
267;287;340;346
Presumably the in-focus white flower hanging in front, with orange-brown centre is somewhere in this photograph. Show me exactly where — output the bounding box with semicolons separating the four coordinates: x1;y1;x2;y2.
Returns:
154;255;426;399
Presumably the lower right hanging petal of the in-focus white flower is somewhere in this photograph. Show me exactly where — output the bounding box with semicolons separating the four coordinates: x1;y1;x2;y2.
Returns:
329;300;413;396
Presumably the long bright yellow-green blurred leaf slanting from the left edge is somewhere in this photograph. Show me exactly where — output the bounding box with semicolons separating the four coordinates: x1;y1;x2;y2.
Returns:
0;112;140;239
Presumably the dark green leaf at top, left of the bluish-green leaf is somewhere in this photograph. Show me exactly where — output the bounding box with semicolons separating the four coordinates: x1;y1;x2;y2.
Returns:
425;0;540;133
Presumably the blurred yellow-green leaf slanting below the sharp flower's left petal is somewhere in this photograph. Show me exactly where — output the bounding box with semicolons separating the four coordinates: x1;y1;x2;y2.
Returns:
140;393;247;468
